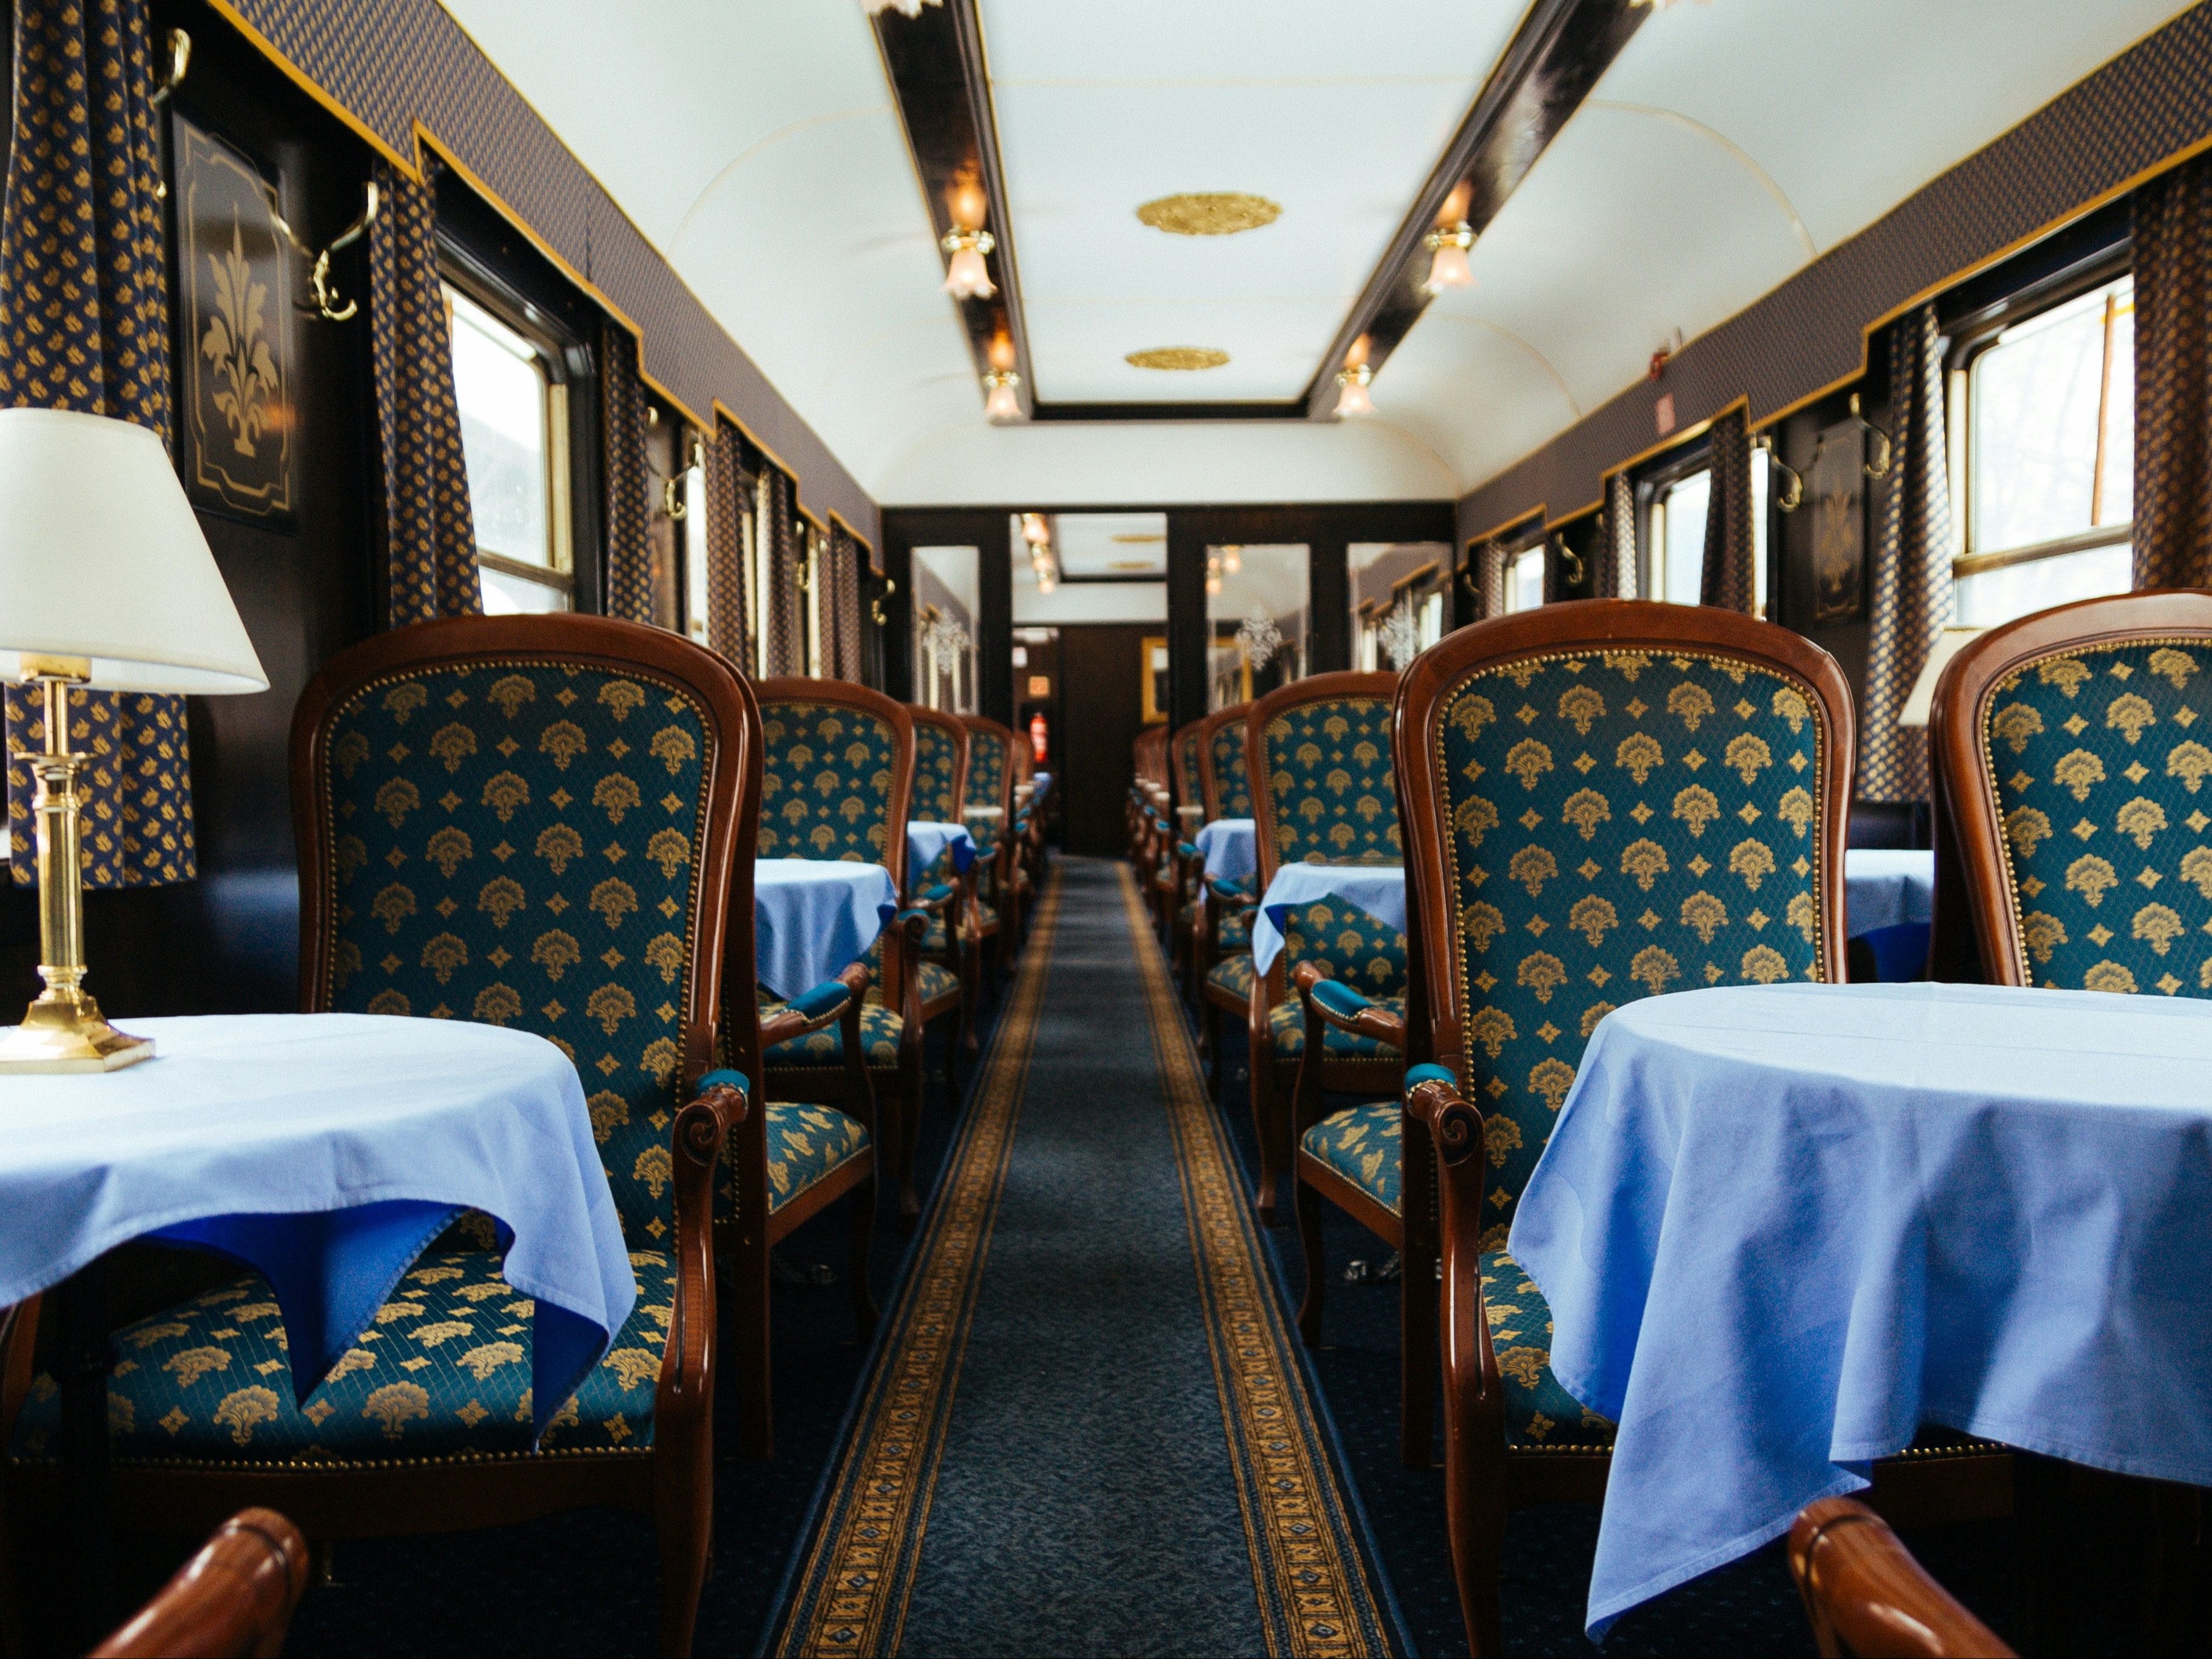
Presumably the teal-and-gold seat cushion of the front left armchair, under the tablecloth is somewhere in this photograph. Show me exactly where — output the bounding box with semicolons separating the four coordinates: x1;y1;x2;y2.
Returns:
13;1256;672;1464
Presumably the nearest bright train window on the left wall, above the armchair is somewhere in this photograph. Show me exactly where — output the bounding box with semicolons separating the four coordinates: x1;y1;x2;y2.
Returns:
445;285;575;615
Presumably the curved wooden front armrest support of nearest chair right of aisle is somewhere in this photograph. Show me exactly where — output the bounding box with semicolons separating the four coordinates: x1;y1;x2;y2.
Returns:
1404;1066;1506;1462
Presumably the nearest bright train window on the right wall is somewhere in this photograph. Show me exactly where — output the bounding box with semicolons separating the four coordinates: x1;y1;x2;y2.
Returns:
1951;277;2134;628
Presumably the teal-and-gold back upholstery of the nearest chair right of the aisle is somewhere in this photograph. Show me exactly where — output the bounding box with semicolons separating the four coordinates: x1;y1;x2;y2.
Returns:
1435;650;1840;1248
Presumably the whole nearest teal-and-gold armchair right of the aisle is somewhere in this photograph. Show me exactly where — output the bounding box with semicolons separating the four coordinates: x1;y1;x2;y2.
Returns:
1398;599;2009;1655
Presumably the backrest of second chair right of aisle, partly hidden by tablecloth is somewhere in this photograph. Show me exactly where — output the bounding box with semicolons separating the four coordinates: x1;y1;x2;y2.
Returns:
1246;675;1404;1002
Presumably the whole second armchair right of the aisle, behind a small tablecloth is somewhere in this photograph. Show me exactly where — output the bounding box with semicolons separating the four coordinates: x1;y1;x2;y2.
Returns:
1246;673;1404;1228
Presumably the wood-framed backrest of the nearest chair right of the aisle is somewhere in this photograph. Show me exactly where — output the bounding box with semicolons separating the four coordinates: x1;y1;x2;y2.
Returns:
1396;599;1853;1250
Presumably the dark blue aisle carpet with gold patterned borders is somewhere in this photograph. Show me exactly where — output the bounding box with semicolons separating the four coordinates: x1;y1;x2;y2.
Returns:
774;858;1404;1655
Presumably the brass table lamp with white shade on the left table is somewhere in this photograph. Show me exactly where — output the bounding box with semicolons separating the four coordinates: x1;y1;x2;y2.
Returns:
0;409;270;1073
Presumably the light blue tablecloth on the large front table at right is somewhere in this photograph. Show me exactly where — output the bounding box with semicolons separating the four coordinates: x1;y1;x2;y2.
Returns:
1511;984;2212;1635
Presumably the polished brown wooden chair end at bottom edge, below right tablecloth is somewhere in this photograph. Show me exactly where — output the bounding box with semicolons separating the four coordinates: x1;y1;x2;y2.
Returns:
1790;1498;2013;1659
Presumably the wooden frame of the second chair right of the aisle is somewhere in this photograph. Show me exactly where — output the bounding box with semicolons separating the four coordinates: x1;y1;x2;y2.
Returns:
1246;670;1407;1228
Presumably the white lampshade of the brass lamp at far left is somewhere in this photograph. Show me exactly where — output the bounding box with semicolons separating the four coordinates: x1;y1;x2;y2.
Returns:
0;409;270;695
